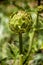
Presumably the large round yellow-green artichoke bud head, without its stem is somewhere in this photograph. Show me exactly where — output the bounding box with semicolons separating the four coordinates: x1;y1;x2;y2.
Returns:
9;11;32;33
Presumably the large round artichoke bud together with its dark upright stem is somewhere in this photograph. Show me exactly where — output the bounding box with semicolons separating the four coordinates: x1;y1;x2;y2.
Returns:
9;11;33;65
